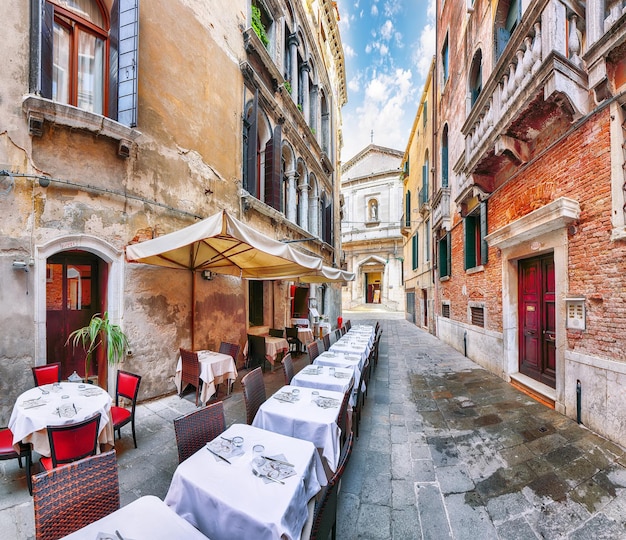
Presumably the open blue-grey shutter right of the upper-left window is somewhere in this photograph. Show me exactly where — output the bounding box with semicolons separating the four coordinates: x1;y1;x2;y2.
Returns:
109;0;139;127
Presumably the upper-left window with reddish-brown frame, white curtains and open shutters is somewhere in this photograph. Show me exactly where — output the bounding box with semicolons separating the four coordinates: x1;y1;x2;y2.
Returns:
30;0;139;127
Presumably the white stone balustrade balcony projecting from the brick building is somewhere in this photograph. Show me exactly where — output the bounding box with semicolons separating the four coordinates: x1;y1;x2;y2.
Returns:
457;0;589;194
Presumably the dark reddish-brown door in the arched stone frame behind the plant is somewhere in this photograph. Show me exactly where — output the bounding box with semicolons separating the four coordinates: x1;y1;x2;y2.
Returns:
46;252;101;379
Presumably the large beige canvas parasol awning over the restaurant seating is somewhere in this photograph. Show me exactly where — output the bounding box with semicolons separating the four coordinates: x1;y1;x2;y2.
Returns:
126;210;322;279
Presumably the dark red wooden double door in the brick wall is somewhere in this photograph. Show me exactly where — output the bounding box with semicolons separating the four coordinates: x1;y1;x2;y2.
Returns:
519;255;556;388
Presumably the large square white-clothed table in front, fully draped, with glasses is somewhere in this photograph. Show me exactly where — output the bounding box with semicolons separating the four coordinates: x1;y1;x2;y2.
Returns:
165;424;327;540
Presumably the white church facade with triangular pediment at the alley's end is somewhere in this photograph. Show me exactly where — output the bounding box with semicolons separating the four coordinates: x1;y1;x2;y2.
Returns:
341;144;404;311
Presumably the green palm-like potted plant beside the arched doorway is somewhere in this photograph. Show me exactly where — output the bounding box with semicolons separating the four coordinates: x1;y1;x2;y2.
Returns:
65;311;128;382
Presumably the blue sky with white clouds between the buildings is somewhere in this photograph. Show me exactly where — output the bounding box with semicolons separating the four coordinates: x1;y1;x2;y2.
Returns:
338;0;435;163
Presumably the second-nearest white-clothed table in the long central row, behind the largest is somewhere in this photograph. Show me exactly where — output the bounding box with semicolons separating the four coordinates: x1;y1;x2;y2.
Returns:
252;385;343;472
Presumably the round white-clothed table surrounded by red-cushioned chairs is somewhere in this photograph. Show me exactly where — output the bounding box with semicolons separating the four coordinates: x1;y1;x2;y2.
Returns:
9;382;115;457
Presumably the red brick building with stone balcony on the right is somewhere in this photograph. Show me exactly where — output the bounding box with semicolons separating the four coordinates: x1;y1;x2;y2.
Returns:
432;0;626;443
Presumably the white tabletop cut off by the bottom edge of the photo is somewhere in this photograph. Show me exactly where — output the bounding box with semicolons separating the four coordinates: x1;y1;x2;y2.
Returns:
62;495;207;540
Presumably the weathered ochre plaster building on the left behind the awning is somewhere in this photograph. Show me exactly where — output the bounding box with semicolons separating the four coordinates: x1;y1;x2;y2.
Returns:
0;0;346;425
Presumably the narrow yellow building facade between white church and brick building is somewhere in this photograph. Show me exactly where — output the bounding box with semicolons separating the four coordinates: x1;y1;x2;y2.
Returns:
401;59;434;333
